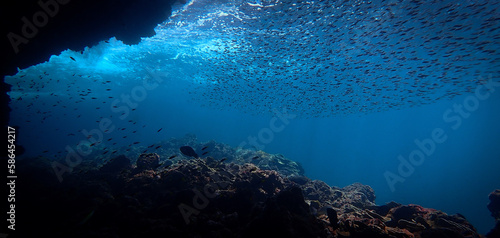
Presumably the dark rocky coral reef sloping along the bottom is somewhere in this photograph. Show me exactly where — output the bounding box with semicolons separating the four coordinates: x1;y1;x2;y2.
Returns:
16;137;500;238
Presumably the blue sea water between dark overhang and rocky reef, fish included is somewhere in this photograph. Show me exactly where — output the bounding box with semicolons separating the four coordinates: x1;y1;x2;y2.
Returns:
6;1;500;233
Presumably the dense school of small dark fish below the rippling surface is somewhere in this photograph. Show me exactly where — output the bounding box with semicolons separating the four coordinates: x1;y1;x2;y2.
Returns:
172;0;500;117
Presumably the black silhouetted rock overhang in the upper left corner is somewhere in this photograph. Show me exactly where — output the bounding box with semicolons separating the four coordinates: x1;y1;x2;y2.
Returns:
0;0;184;152
